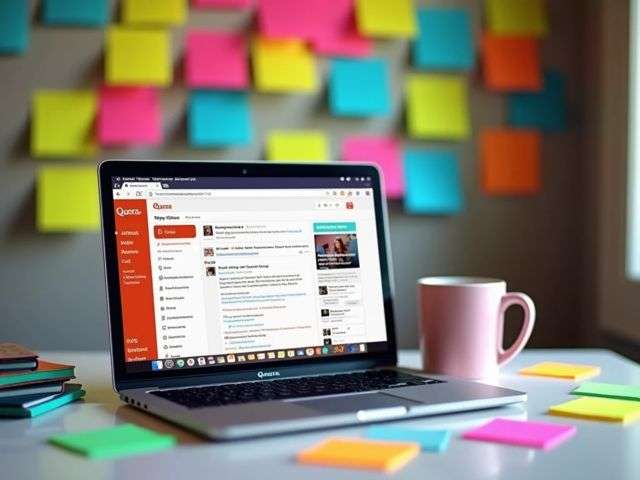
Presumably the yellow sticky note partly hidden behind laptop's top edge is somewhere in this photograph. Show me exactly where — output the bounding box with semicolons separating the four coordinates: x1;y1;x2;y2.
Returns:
266;130;329;162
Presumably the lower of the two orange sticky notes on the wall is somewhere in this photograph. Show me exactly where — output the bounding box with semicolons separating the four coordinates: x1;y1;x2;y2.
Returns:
480;128;541;195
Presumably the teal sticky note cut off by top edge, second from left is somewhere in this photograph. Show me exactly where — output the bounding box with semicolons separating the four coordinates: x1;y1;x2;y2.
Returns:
42;0;109;27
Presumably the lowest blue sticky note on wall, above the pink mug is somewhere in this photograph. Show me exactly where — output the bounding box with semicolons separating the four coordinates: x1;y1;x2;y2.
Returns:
404;149;463;215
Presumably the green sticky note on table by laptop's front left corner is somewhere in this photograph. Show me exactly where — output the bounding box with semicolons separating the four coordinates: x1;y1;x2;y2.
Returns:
49;423;176;459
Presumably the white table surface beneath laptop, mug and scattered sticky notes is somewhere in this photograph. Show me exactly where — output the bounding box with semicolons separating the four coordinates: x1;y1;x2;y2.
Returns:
0;350;640;480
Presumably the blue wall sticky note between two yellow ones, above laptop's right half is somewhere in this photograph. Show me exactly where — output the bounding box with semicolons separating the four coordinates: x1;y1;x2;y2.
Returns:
329;58;391;117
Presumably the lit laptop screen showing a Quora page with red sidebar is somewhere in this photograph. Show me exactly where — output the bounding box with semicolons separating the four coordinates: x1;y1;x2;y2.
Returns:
111;177;387;373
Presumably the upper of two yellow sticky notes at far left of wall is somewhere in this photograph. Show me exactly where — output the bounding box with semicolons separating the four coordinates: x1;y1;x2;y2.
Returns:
31;90;96;157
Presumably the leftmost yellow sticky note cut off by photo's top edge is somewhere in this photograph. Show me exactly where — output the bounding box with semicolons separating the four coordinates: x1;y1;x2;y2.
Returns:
122;0;187;25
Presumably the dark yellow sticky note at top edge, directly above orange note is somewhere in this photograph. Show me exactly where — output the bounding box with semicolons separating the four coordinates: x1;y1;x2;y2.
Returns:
485;0;549;37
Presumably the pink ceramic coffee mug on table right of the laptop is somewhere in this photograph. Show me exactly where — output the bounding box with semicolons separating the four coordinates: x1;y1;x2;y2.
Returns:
418;277;536;379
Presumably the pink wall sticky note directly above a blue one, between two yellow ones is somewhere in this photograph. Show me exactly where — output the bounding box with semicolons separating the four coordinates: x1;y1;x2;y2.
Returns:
184;30;249;89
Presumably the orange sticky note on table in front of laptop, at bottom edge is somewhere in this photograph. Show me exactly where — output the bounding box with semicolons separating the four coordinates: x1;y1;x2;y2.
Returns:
298;438;420;473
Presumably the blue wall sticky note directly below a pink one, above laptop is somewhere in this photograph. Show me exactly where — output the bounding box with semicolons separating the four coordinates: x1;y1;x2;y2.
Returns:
188;90;253;148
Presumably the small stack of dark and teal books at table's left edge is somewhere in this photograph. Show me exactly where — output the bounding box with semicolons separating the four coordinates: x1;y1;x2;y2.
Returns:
0;343;85;418
